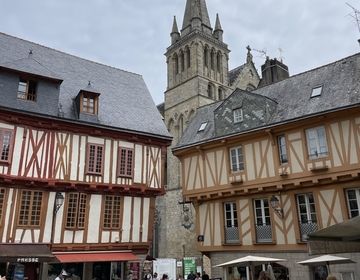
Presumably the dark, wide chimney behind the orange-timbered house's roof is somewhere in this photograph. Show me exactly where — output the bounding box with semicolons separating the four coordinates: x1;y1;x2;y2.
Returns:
259;57;289;87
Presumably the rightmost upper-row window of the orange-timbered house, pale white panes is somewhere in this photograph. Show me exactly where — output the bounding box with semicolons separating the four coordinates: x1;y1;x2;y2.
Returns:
306;126;328;159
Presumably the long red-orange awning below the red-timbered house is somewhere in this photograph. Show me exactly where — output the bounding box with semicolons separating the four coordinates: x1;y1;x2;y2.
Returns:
54;251;139;263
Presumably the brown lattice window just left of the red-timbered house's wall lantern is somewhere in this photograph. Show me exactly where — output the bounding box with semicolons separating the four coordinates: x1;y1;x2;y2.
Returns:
18;191;43;226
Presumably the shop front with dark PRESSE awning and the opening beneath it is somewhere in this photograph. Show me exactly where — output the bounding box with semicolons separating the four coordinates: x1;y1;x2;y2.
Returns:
0;244;57;280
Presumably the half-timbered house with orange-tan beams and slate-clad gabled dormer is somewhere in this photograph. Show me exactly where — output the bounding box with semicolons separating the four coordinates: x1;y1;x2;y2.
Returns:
173;54;360;280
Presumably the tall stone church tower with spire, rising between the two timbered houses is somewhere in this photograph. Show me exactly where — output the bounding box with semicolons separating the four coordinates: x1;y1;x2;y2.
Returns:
156;0;260;266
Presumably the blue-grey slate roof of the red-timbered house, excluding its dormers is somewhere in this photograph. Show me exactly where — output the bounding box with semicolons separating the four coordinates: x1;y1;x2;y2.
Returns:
0;32;171;138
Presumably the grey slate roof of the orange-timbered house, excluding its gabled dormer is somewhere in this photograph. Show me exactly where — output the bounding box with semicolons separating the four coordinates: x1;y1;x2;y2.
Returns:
174;53;360;150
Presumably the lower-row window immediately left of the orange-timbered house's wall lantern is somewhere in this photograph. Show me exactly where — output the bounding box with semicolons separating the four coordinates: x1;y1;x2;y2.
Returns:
254;199;272;243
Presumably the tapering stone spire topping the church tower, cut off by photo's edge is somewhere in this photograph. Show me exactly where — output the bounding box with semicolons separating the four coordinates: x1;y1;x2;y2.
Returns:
181;0;212;35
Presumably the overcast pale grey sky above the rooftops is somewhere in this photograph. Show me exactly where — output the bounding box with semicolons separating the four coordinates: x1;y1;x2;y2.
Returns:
0;0;360;104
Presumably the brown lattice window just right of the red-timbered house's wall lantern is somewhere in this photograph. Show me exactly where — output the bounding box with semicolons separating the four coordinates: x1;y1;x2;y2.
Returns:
66;193;87;229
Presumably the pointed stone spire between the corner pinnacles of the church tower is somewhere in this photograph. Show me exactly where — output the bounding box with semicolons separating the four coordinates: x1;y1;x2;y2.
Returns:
182;0;211;30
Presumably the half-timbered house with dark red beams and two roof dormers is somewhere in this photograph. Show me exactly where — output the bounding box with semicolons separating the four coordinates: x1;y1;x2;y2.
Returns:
0;33;171;279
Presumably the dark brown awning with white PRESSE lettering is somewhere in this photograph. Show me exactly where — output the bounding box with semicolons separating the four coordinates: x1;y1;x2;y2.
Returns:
0;243;57;263
